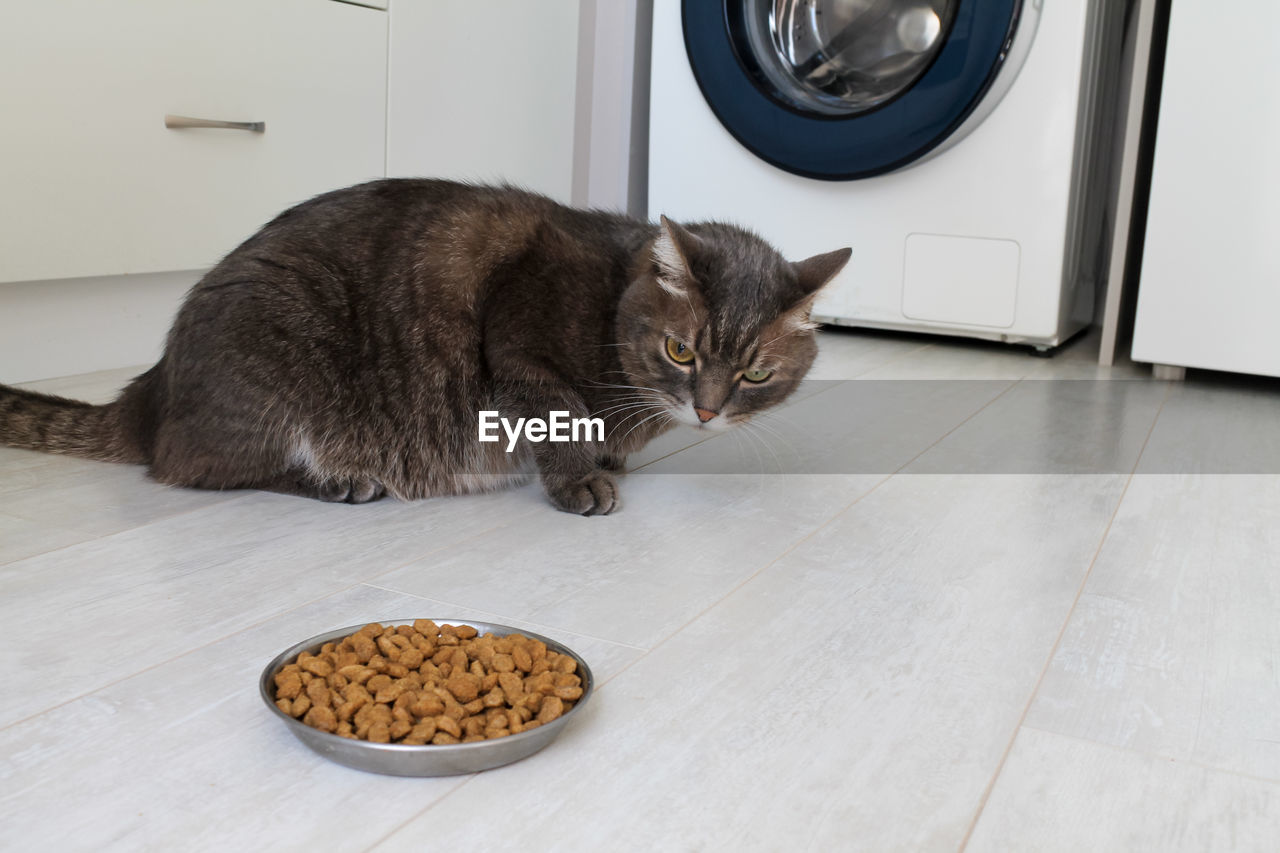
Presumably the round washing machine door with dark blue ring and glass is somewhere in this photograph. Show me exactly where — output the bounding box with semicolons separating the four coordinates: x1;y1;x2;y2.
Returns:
682;0;1041;181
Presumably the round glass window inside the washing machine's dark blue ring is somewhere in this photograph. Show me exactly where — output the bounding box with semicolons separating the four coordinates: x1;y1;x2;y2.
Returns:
740;0;957;115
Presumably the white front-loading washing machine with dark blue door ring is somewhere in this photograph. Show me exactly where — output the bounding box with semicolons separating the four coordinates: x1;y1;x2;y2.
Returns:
649;0;1132;350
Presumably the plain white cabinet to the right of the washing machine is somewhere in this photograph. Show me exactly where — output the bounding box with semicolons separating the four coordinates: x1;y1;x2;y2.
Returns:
1133;0;1280;377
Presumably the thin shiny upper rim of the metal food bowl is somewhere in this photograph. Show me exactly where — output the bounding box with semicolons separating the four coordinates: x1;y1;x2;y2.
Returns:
257;616;595;754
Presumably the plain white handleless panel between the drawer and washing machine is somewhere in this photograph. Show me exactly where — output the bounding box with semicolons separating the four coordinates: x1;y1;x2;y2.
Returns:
387;0;579;202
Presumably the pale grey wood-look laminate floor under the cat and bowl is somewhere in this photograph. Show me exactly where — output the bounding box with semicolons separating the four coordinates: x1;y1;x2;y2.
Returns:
0;330;1280;853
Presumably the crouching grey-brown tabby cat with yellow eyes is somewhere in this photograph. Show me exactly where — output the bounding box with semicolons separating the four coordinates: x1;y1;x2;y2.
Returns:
0;178;851;515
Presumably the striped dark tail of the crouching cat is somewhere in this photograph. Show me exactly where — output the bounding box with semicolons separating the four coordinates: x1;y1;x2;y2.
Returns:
0;365;160;464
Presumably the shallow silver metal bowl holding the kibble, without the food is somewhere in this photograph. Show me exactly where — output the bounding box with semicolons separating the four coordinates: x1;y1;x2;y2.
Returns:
259;619;595;776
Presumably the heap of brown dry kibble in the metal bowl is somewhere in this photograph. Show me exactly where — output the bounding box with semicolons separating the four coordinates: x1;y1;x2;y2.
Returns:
275;619;582;744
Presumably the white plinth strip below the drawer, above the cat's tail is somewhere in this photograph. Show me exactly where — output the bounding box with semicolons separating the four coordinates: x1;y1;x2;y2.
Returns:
0;270;204;384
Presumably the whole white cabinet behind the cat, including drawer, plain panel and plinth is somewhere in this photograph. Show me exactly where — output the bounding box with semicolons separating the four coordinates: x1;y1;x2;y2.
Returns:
0;0;580;383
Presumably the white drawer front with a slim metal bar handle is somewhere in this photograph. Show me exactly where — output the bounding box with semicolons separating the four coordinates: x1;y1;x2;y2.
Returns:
0;0;387;282
